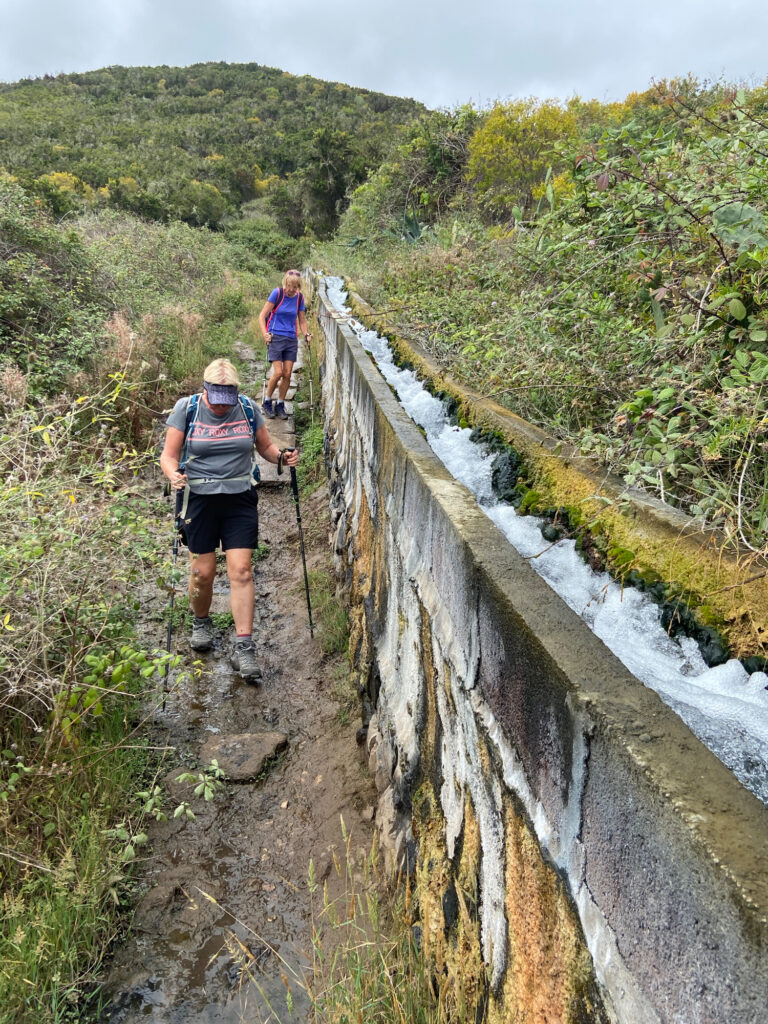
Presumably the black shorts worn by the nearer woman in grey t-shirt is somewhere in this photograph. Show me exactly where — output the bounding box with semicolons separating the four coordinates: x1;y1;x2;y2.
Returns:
176;487;259;555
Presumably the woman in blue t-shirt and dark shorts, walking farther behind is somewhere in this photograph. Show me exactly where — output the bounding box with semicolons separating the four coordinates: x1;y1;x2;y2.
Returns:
259;270;312;420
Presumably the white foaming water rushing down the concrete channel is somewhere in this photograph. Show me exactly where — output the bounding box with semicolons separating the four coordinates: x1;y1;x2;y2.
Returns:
326;278;768;804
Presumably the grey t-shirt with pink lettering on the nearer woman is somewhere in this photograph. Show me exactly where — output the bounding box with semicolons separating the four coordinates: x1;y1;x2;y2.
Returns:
166;395;264;495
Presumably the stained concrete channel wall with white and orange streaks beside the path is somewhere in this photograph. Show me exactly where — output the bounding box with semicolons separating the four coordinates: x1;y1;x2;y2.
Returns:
321;282;768;1024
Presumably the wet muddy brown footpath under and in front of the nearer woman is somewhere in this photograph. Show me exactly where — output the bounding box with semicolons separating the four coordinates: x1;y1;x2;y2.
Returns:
104;444;375;1024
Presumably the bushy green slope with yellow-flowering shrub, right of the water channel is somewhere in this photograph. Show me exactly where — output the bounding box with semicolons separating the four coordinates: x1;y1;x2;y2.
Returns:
316;80;768;551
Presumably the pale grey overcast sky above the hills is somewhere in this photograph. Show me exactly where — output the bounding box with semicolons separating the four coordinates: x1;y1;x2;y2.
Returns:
0;0;768;106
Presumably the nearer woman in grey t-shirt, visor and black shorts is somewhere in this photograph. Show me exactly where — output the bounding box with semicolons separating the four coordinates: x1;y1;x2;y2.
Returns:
160;359;299;681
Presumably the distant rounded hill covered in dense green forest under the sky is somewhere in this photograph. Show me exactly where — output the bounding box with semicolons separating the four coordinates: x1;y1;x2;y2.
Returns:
0;63;424;237
